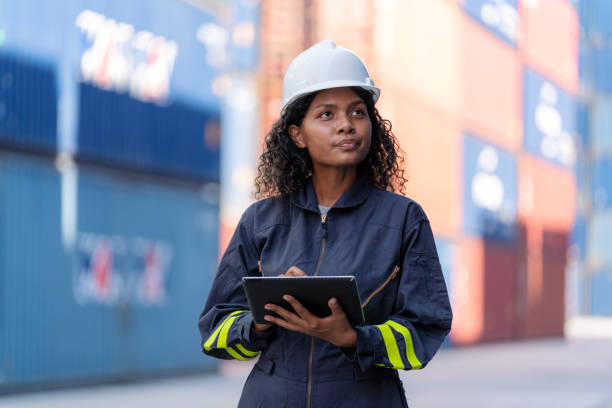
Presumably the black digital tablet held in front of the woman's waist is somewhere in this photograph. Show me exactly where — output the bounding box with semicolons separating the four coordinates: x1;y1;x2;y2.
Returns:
242;276;364;325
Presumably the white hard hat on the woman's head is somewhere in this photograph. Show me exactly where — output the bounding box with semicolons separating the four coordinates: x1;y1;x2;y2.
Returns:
281;40;380;114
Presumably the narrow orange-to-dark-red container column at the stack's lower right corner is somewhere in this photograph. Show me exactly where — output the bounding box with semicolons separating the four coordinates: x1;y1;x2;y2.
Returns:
517;154;576;337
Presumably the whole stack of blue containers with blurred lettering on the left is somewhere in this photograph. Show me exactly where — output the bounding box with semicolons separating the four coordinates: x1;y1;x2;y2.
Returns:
0;0;230;392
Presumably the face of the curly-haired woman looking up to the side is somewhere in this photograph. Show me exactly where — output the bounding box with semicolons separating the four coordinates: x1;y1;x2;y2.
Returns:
289;88;372;171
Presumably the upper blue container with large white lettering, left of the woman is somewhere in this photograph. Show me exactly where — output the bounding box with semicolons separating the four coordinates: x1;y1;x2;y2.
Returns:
75;0;222;180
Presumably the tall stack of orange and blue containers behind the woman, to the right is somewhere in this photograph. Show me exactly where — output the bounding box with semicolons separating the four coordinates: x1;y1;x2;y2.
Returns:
262;0;578;344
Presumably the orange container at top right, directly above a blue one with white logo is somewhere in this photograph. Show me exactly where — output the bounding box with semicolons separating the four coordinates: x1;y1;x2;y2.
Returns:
519;0;579;92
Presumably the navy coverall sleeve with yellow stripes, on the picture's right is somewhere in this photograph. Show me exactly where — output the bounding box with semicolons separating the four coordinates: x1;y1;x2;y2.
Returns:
349;214;452;371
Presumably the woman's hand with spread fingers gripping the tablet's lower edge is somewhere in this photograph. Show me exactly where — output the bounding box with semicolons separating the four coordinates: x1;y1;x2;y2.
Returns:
265;295;357;347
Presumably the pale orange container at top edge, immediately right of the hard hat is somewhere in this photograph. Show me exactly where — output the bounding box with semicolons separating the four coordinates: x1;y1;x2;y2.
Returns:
374;0;465;115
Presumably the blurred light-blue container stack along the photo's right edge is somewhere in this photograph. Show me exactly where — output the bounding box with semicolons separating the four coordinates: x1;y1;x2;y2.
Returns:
572;0;612;316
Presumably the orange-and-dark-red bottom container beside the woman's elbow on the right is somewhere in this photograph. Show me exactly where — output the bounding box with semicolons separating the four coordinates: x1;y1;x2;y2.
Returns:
451;239;517;344
